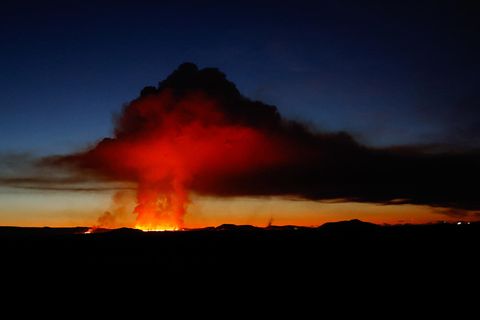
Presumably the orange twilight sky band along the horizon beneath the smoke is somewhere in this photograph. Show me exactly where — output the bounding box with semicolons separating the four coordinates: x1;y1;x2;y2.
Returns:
0;191;479;231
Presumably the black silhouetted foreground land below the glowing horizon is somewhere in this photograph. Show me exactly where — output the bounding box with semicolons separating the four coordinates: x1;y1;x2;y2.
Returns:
0;221;480;308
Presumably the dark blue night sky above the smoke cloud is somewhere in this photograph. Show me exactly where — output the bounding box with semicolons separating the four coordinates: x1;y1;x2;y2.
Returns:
0;1;480;154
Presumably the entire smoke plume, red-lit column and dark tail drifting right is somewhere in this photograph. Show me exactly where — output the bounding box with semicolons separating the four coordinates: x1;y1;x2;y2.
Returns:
47;63;480;229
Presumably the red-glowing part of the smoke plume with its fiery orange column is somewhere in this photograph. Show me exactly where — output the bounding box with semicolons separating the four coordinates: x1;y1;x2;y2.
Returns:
71;90;283;230
